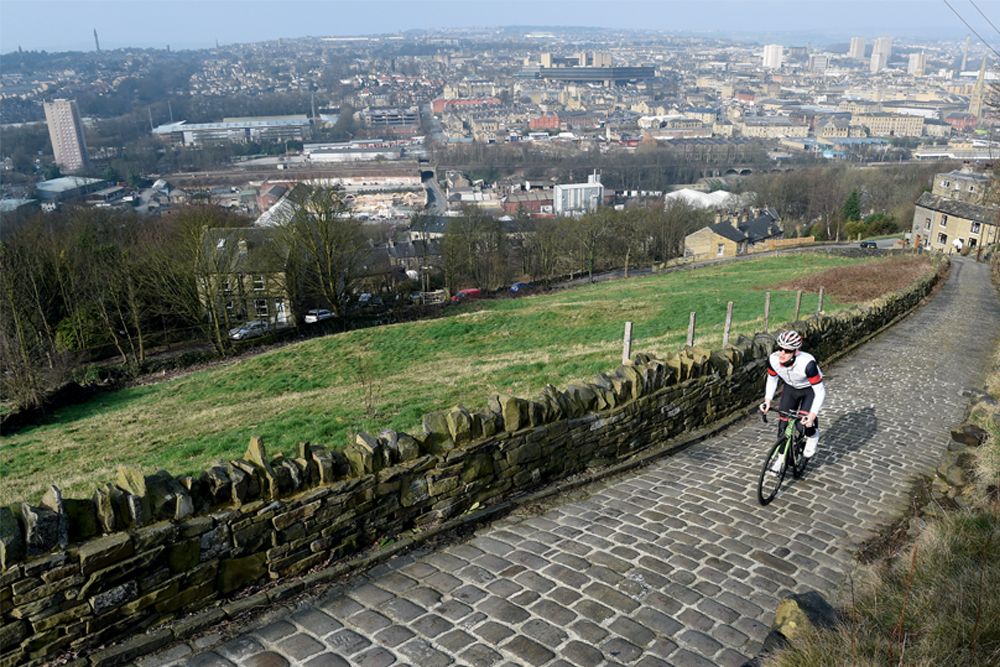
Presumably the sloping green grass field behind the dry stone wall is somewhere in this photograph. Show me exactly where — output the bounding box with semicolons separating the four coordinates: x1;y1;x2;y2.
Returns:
0;254;928;504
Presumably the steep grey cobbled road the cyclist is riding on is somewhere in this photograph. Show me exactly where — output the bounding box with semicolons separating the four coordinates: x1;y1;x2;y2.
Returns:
154;259;1000;667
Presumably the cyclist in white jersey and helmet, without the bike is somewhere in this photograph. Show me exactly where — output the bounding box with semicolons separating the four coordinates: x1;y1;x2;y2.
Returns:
760;330;826;466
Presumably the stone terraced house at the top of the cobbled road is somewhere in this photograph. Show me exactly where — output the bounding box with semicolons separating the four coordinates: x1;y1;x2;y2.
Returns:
912;164;1000;252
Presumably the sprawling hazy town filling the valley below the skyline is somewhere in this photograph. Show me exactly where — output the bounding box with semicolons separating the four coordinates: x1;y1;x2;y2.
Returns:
0;29;997;221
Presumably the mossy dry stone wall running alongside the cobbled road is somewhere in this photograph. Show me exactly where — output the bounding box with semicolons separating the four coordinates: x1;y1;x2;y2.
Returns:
0;264;936;667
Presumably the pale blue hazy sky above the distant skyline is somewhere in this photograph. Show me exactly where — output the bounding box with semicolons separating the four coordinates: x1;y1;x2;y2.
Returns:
0;0;1000;53
